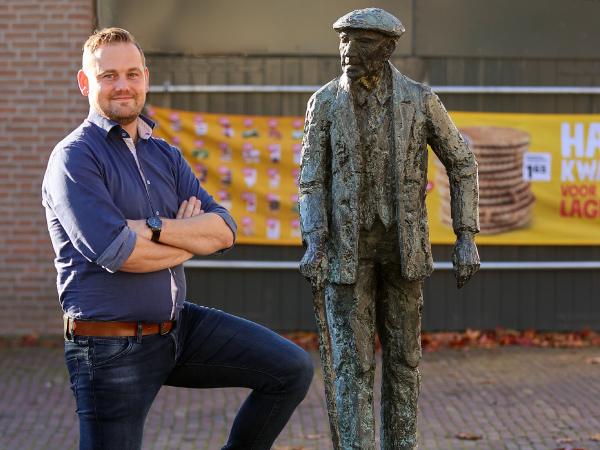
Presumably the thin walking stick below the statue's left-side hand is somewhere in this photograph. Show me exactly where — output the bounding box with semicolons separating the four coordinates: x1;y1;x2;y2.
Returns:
312;283;342;450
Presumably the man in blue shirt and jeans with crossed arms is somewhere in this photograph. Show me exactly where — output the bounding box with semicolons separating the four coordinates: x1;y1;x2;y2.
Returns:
42;28;313;450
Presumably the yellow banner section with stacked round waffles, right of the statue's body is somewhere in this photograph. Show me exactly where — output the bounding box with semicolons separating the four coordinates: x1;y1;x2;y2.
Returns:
427;112;600;245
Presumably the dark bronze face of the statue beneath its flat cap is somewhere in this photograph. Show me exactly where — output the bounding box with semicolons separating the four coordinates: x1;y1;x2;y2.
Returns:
340;28;395;80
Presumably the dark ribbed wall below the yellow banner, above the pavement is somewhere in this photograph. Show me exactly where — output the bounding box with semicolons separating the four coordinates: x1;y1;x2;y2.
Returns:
186;245;600;331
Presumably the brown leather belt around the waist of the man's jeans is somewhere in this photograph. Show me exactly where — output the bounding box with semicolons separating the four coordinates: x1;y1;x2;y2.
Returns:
65;319;173;337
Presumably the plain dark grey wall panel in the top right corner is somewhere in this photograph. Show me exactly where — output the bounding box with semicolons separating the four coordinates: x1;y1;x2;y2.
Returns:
414;0;600;58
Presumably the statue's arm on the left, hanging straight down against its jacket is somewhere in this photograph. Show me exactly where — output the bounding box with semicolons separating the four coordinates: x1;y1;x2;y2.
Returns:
298;94;331;287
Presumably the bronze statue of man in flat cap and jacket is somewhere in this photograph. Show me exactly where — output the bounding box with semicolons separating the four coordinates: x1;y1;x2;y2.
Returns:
299;8;479;450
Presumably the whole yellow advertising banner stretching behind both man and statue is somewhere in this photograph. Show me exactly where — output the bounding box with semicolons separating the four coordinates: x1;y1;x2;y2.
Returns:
148;107;600;245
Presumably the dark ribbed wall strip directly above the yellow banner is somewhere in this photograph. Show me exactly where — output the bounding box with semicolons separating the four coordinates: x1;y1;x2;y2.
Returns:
148;55;600;116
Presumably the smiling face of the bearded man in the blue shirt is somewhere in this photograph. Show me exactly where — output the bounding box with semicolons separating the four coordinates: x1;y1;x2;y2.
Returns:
77;43;149;125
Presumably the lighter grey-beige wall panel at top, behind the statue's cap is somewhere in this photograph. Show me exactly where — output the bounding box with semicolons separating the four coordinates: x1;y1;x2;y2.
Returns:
97;0;413;55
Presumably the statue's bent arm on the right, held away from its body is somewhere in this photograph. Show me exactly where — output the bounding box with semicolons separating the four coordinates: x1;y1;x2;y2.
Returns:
426;91;480;288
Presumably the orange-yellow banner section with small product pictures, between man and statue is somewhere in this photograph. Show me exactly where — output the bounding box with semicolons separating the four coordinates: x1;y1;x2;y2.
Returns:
148;107;304;245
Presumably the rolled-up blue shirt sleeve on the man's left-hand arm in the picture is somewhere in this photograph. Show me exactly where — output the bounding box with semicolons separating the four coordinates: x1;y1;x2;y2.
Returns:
42;142;137;272
